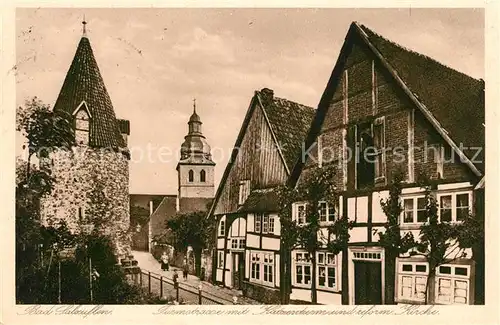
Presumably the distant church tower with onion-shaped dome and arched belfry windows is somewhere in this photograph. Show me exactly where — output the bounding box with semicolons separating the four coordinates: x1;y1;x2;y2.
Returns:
177;102;215;200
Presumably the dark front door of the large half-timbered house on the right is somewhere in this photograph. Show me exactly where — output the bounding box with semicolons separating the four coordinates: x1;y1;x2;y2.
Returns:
354;261;382;305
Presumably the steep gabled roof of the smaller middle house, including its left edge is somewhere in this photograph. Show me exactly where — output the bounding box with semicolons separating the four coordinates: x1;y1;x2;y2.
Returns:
208;88;314;217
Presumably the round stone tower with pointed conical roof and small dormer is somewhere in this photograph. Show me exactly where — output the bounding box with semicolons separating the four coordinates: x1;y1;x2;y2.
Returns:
40;21;130;258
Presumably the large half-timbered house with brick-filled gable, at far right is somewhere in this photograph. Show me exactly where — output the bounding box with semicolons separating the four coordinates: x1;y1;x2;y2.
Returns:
290;23;485;304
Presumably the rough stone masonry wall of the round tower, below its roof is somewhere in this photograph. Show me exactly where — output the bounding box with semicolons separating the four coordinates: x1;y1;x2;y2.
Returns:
42;147;131;258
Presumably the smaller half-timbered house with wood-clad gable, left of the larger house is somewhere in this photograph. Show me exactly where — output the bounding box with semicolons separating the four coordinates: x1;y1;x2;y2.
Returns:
208;88;314;302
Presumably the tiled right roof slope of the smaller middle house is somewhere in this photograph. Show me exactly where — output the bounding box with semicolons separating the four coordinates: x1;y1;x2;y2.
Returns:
257;88;315;169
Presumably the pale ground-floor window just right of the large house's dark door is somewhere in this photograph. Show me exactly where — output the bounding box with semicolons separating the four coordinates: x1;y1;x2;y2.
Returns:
397;262;428;301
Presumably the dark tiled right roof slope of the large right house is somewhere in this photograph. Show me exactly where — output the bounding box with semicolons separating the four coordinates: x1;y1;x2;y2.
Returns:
360;25;485;171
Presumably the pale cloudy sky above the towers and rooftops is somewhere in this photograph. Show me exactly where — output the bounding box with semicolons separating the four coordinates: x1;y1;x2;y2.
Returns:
16;8;484;194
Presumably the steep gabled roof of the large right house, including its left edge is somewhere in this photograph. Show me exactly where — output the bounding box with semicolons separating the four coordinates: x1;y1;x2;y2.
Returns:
289;22;485;185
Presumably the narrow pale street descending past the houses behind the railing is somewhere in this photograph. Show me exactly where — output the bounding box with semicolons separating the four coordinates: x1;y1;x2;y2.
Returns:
132;251;260;305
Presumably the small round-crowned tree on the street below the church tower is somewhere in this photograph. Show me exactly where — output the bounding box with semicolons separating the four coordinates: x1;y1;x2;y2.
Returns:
166;211;215;276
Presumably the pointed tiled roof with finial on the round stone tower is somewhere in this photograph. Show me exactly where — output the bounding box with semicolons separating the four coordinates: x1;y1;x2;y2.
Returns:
54;20;126;148
